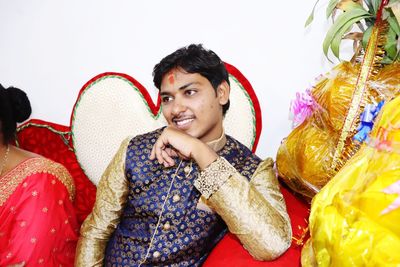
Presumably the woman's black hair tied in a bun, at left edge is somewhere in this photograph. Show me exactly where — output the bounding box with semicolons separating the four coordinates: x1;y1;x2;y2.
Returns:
0;84;32;144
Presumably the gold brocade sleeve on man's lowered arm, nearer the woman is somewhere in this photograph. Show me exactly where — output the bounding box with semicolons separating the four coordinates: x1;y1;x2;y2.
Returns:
75;138;131;267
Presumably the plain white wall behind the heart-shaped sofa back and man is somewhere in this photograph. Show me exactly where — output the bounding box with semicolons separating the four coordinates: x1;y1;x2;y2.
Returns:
0;0;346;157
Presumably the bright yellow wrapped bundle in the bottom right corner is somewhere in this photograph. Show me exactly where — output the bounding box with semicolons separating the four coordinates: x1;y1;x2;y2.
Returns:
301;97;400;266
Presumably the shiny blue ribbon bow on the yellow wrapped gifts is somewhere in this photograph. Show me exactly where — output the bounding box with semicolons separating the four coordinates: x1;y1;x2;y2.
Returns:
353;101;384;143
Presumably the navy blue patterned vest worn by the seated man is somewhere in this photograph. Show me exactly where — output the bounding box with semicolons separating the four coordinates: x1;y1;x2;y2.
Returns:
105;129;261;266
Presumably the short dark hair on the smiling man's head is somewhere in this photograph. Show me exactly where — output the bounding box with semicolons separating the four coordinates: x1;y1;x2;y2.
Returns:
153;44;229;115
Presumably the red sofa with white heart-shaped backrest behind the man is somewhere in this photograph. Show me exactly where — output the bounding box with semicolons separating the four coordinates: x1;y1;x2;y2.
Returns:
17;64;309;267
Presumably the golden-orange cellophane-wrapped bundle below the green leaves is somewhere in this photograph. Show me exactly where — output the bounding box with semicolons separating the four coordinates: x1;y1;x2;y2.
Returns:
277;62;400;199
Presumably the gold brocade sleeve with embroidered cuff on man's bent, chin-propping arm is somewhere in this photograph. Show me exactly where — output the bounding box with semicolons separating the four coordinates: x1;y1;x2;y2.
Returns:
195;157;292;260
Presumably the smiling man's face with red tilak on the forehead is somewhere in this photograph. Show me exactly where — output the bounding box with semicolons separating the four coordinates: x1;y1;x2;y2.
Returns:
160;69;229;142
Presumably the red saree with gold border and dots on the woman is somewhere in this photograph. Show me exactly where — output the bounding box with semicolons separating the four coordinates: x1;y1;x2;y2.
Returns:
0;158;79;266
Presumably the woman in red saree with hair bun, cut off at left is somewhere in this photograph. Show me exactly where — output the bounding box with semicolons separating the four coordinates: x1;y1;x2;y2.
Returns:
0;85;79;266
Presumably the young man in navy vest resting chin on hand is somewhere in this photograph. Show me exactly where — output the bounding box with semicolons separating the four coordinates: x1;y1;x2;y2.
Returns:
76;45;291;267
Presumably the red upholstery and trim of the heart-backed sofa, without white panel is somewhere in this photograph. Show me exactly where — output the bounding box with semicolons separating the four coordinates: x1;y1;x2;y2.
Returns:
17;67;308;266
